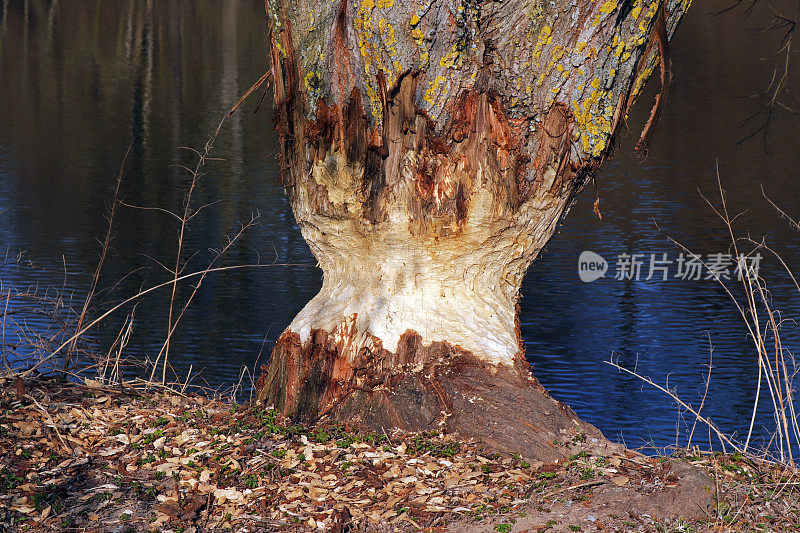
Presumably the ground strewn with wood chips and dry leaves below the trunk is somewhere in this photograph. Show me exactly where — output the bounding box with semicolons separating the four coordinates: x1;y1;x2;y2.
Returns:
0;378;800;533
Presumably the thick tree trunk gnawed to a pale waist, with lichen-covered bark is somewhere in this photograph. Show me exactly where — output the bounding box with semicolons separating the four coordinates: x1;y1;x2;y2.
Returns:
259;0;689;459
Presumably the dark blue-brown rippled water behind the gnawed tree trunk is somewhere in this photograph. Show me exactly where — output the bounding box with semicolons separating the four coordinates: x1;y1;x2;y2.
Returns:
0;0;800;454
